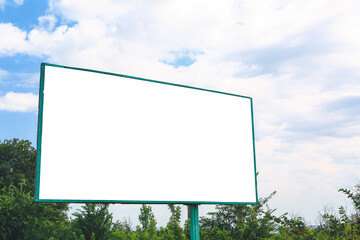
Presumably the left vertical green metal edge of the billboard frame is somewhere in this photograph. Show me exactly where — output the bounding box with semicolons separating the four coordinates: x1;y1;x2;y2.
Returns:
35;63;46;199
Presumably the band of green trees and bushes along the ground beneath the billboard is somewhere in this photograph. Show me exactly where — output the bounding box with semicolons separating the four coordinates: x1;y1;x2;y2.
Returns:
0;139;360;240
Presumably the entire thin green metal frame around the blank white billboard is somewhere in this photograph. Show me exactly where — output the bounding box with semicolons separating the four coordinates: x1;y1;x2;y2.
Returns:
35;63;259;205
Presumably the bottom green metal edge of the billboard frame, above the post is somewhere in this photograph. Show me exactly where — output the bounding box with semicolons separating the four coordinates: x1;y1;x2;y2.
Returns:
35;198;258;205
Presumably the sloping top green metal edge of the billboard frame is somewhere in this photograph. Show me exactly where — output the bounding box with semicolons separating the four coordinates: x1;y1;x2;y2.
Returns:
42;63;251;99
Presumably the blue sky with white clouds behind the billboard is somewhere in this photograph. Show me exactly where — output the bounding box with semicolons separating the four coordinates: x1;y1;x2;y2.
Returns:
0;0;360;225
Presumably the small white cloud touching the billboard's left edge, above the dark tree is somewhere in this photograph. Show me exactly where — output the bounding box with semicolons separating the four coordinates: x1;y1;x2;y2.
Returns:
0;92;38;112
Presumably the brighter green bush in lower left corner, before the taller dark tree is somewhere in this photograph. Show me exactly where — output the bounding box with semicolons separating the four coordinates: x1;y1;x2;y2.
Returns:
0;185;68;239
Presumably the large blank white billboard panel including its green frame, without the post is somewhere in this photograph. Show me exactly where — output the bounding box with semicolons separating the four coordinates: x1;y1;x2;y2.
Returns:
36;64;257;204
